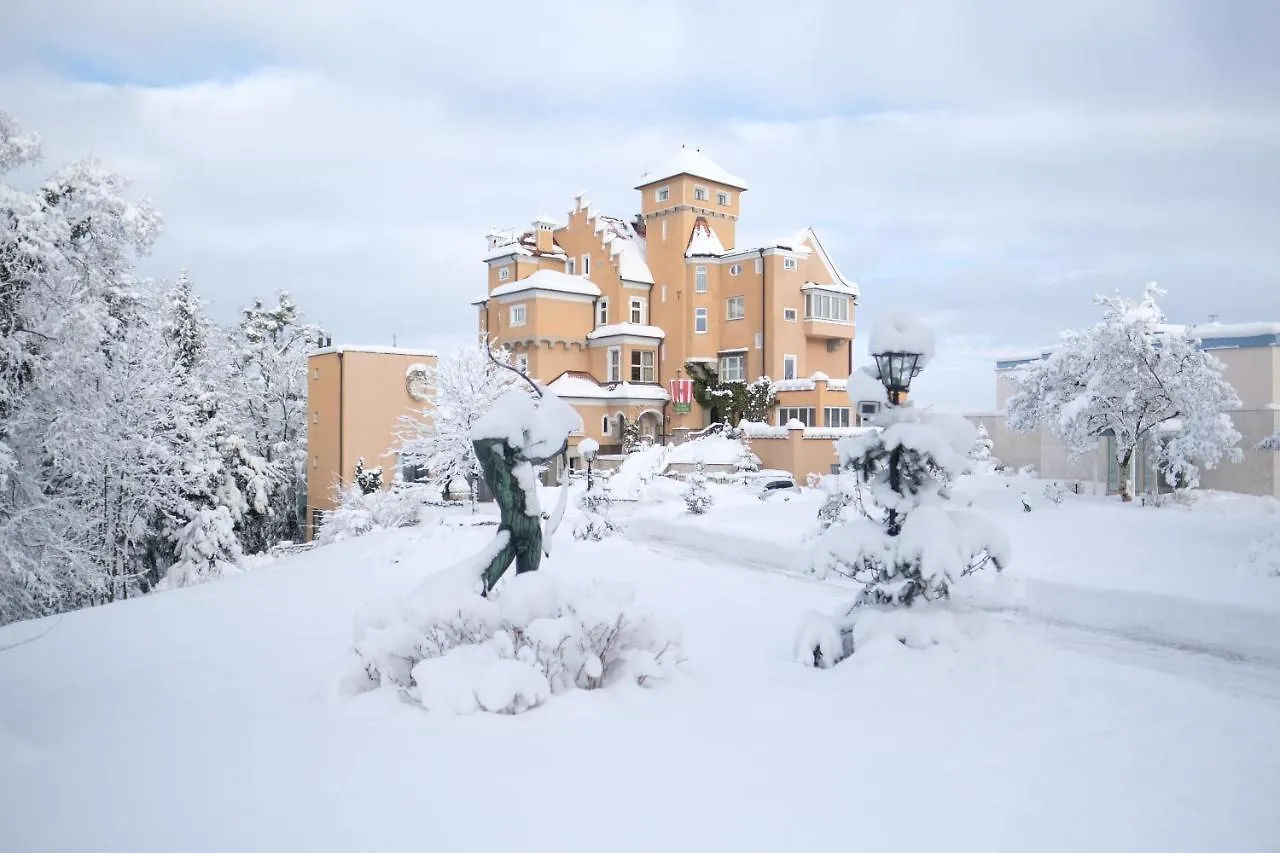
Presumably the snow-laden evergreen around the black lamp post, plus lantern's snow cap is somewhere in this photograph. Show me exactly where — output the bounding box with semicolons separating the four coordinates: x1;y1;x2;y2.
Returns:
797;316;1009;666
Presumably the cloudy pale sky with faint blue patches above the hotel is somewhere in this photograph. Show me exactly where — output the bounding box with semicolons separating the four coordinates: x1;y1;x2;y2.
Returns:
0;0;1280;409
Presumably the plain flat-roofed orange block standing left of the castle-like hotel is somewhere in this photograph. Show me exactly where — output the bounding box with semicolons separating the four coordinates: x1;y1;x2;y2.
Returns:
307;350;435;529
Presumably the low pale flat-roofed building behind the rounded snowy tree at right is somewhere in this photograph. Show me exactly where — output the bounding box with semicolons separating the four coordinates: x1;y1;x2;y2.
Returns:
970;323;1280;497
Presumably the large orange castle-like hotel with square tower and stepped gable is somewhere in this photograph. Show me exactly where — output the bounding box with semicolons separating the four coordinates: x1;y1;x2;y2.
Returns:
476;147;858;461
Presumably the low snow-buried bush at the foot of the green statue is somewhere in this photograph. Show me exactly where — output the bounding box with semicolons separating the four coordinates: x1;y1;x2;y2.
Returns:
343;563;681;713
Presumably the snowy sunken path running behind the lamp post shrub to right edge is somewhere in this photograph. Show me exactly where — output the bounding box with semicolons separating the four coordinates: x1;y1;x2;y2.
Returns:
621;517;1280;684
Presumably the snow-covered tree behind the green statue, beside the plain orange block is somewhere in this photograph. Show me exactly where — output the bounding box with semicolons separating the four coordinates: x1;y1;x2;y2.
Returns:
398;345;525;492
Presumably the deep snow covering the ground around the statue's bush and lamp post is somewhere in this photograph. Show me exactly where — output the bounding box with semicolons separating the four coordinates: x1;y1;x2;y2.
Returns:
0;476;1280;853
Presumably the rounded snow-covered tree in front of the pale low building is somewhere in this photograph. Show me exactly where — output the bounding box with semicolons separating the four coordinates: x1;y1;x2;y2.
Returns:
1007;284;1240;501
